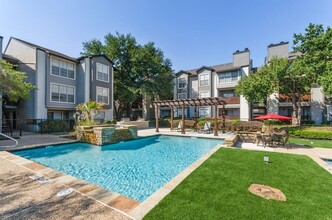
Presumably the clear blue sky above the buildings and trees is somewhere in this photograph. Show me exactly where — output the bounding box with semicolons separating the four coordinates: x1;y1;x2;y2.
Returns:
0;0;332;71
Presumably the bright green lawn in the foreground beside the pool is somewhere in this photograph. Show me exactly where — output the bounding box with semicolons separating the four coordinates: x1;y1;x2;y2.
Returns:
144;148;332;220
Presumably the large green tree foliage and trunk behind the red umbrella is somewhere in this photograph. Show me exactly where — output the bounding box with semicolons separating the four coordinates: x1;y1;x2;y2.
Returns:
236;24;332;125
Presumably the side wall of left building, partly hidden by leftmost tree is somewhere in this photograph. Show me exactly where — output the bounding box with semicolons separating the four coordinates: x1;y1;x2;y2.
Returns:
4;39;38;119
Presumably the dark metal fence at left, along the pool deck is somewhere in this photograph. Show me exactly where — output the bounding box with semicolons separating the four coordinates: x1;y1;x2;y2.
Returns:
0;119;75;137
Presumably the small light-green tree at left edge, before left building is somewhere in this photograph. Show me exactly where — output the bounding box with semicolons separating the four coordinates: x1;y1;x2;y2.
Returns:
0;60;37;101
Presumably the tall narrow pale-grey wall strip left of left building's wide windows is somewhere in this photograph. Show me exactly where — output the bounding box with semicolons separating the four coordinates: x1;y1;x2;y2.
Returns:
34;50;48;119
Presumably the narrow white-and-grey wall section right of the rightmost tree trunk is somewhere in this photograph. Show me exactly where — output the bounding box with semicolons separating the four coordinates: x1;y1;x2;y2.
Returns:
310;87;325;124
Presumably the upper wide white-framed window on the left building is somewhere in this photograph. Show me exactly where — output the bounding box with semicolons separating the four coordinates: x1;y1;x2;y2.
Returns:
51;58;75;79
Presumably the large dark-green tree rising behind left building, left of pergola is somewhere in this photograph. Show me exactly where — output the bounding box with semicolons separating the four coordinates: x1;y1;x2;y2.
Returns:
82;33;173;118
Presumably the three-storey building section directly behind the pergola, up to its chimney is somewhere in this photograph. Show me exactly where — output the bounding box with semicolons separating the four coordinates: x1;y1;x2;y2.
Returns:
174;48;252;121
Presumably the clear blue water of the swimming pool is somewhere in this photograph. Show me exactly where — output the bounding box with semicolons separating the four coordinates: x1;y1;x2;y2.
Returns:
15;136;223;202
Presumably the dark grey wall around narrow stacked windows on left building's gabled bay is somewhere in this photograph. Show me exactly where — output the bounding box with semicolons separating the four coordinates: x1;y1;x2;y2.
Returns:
90;57;113;109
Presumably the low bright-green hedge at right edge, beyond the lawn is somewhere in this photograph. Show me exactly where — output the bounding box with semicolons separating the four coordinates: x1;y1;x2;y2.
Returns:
289;128;332;140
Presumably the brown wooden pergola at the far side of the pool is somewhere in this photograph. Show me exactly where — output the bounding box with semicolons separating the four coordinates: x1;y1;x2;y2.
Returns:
153;97;226;136
